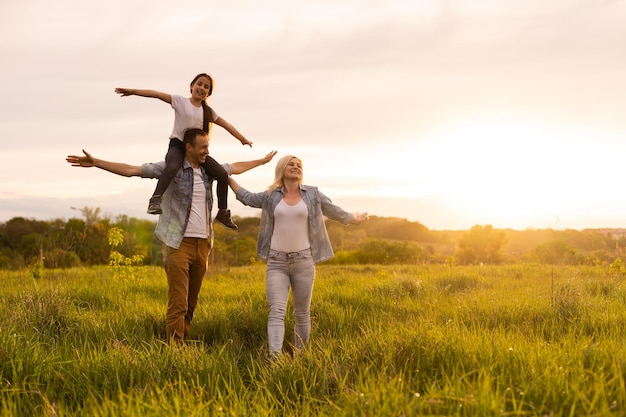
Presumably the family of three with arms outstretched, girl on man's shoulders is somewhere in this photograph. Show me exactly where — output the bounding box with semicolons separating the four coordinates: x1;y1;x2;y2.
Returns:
66;74;368;357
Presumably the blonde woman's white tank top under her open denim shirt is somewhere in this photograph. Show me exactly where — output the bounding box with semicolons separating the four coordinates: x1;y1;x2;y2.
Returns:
270;200;311;252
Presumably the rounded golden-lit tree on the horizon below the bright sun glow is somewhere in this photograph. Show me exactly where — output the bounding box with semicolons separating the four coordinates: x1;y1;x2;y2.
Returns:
457;224;506;264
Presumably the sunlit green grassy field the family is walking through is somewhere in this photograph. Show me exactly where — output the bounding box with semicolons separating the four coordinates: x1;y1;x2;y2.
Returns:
0;264;626;417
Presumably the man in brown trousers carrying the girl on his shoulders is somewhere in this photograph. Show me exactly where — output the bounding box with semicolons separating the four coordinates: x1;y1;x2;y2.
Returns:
66;129;276;342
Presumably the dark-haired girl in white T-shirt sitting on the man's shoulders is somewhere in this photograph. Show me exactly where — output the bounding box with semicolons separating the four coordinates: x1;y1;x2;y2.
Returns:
115;73;252;230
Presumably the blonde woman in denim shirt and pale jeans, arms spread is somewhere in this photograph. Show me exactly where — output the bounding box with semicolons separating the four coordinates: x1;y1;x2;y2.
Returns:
229;155;367;357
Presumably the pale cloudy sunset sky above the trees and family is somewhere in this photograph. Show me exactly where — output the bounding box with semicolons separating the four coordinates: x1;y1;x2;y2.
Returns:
0;0;626;230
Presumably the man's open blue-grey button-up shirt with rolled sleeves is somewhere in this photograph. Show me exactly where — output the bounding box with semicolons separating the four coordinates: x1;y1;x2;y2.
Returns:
141;159;232;249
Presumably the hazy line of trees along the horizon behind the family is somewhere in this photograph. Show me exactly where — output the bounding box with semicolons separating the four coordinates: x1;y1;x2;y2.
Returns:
0;207;626;269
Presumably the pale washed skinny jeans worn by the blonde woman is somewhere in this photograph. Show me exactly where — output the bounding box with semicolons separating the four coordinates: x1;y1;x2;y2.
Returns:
265;249;315;355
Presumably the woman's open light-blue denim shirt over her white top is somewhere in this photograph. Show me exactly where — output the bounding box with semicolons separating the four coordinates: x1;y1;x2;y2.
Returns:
237;185;354;263
